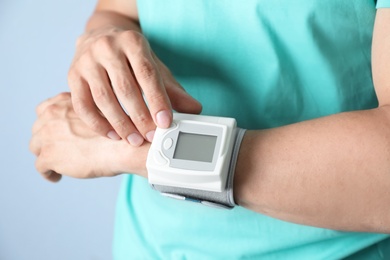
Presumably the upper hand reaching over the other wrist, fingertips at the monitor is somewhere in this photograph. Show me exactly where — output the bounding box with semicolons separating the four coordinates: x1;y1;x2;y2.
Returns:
68;28;202;146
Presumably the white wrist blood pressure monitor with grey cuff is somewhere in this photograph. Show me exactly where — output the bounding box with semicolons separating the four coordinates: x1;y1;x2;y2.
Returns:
146;113;245;208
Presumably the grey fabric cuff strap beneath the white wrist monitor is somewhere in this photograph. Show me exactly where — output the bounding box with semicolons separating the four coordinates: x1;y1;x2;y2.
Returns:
151;128;246;209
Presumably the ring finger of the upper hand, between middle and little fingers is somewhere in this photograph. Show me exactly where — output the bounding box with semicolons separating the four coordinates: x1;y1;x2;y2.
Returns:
89;66;144;146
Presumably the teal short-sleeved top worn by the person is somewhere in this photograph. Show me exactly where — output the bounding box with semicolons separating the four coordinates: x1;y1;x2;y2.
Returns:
113;0;390;260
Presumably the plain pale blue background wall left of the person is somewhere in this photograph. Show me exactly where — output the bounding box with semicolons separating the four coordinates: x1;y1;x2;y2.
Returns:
0;0;120;260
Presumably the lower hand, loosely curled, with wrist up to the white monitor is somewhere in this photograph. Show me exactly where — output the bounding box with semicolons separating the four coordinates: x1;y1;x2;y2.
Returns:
30;93;149;182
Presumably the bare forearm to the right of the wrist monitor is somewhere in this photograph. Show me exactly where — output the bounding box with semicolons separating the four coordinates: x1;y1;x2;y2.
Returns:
234;107;390;232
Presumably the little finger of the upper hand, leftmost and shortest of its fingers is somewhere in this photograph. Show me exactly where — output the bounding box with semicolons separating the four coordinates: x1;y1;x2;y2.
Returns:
72;78;120;140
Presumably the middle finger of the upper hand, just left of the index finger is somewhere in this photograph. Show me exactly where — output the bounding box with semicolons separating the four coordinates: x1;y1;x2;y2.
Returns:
106;53;156;141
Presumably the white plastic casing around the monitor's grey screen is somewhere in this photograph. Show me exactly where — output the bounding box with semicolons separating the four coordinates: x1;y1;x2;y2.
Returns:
146;113;236;192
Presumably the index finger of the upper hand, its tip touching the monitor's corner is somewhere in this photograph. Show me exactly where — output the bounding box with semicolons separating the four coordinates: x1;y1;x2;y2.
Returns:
126;36;172;128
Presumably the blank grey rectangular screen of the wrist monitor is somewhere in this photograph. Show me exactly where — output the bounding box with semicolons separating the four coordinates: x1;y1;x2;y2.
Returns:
173;132;217;163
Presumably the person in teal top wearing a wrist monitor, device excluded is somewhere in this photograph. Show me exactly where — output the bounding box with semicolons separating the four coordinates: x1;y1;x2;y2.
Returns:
31;0;390;259
